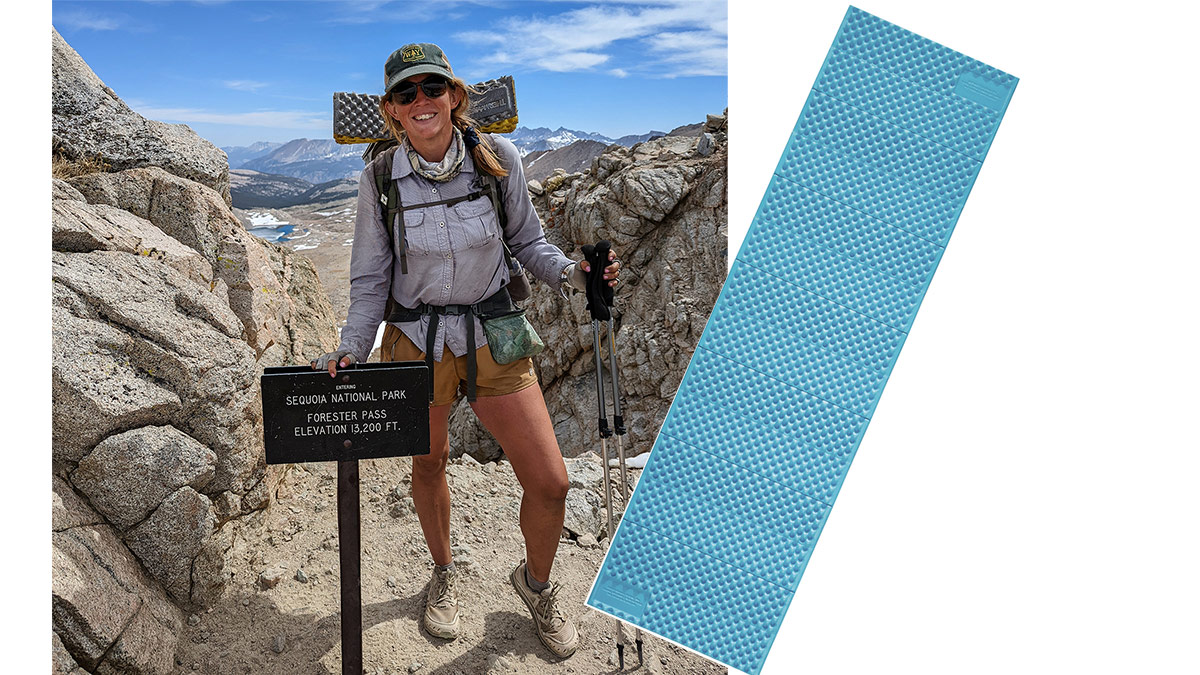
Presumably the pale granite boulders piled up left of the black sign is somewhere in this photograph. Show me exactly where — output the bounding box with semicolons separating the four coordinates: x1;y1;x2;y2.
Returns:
52;31;337;673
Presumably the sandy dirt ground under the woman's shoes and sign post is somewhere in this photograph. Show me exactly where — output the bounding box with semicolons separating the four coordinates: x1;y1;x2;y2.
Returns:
179;458;726;675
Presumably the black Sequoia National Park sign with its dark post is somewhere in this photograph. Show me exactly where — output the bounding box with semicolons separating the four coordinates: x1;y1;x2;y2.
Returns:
262;362;430;675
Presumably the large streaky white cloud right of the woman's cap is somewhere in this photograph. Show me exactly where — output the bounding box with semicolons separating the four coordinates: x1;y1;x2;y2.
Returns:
455;0;728;77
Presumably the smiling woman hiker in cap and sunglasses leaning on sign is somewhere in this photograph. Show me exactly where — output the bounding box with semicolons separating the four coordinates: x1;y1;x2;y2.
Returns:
312;43;620;657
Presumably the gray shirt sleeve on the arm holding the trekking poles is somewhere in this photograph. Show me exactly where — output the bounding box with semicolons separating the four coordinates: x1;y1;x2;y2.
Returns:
492;136;571;292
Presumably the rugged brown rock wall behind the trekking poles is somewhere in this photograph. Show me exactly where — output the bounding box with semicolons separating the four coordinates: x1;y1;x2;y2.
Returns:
451;114;728;459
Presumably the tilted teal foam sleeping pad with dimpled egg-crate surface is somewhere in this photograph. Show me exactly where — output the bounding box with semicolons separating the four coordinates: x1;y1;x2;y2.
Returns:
587;7;1016;674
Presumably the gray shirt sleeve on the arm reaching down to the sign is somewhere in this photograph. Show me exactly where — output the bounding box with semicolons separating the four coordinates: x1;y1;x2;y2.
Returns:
338;165;392;363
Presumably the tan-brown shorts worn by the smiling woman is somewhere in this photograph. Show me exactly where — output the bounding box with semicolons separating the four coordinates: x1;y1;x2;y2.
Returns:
379;323;538;406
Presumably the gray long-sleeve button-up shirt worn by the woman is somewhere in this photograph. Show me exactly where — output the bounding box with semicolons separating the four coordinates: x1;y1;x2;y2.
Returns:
338;136;571;363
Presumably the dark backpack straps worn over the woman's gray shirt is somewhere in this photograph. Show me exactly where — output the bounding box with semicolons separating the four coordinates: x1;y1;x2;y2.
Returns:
362;138;532;319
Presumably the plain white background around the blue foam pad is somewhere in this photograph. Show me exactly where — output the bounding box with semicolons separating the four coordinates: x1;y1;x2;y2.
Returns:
714;1;1200;674
